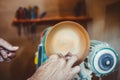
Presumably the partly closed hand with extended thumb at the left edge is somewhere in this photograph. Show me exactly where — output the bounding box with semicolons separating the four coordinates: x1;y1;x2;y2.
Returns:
0;38;19;62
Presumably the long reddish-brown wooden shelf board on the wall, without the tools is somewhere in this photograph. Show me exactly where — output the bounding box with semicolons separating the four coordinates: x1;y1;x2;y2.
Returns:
13;16;92;24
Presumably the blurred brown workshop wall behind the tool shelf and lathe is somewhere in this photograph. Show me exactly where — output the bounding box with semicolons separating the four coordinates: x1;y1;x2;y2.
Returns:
0;0;120;80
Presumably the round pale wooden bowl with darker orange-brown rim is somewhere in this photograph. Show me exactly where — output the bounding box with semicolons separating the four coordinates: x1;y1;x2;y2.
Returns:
45;21;90;63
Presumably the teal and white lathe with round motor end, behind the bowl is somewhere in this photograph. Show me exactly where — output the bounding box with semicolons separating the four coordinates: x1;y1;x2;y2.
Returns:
37;28;118;80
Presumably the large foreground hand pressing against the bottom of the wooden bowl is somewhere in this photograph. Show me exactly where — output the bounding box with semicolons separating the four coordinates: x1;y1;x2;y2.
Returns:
28;55;80;80
